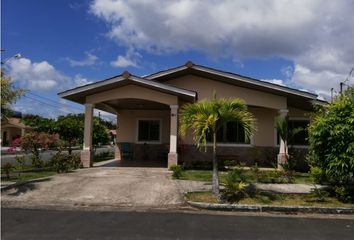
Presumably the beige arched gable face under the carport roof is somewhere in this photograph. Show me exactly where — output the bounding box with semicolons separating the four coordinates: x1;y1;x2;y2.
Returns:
86;84;178;105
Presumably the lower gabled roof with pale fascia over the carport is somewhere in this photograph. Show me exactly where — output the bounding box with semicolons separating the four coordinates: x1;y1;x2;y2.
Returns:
58;71;197;104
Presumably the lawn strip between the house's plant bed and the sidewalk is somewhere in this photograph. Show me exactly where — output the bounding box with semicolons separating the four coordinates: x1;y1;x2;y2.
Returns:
180;170;313;184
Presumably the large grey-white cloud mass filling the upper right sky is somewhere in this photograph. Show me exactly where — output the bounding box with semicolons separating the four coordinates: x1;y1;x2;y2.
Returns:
90;0;354;99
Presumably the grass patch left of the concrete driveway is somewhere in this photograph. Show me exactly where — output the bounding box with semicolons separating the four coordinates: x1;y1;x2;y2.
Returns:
1;168;58;182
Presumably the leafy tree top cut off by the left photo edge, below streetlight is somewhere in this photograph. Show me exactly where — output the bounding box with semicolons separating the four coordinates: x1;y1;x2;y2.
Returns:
1;68;25;119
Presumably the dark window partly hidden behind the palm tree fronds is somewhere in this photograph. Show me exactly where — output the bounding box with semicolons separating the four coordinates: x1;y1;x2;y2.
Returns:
207;122;250;144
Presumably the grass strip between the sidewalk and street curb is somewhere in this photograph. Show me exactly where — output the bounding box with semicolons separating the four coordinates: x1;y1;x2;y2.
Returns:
185;192;354;208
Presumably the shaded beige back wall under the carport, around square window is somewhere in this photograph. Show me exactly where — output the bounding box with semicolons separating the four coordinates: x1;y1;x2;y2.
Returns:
117;110;170;144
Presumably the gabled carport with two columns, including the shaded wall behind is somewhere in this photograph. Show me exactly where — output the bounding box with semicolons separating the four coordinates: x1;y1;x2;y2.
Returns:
60;72;196;167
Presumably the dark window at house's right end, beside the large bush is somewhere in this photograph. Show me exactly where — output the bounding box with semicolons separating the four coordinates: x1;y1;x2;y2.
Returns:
277;120;309;146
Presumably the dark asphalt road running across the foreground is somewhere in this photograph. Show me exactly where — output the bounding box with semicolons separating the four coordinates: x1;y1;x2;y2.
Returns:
2;208;354;240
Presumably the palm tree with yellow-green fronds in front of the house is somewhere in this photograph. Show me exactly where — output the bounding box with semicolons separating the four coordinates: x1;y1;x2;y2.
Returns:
180;93;255;196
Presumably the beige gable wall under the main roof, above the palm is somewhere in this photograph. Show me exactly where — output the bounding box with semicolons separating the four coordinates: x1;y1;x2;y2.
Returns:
166;75;287;109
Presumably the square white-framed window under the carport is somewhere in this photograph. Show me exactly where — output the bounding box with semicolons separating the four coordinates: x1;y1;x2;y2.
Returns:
138;120;160;142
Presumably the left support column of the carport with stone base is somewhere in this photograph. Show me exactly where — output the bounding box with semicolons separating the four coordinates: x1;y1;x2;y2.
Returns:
81;103;94;168
